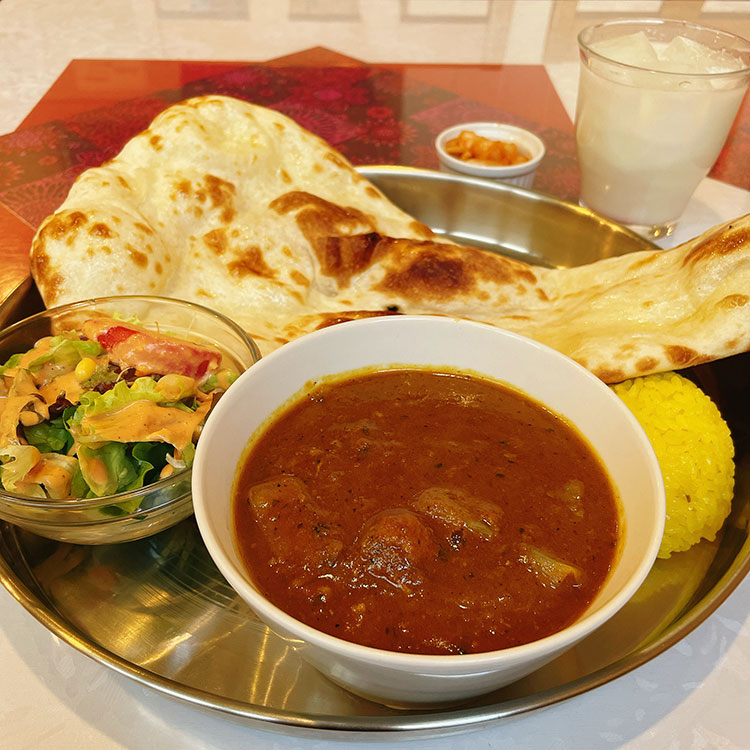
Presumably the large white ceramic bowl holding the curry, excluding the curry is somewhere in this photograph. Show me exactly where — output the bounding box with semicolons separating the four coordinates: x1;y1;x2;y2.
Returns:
193;316;665;706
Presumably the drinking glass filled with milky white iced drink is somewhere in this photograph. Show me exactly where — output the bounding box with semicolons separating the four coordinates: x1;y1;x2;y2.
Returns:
576;19;750;238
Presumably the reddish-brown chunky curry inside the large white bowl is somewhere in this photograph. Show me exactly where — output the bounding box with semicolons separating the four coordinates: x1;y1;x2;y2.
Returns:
234;369;618;654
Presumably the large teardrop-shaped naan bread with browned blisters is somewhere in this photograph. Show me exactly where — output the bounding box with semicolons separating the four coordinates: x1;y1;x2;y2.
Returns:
31;96;750;383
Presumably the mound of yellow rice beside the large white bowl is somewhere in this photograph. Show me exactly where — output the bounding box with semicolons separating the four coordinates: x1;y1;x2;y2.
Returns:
613;372;734;558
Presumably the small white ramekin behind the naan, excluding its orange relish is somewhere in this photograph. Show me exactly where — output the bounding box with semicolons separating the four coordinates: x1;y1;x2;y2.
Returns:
435;122;545;188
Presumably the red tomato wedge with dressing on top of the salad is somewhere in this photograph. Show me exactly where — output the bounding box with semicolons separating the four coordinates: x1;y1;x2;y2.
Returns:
83;318;221;380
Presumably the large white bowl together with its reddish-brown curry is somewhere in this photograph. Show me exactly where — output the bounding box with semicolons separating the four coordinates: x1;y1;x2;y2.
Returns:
193;316;665;706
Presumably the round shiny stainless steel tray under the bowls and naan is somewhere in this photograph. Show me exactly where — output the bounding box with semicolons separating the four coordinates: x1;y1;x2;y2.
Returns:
0;167;750;736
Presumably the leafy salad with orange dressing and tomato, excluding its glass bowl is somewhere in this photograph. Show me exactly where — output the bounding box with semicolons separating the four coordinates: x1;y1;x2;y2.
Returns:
0;318;237;506
